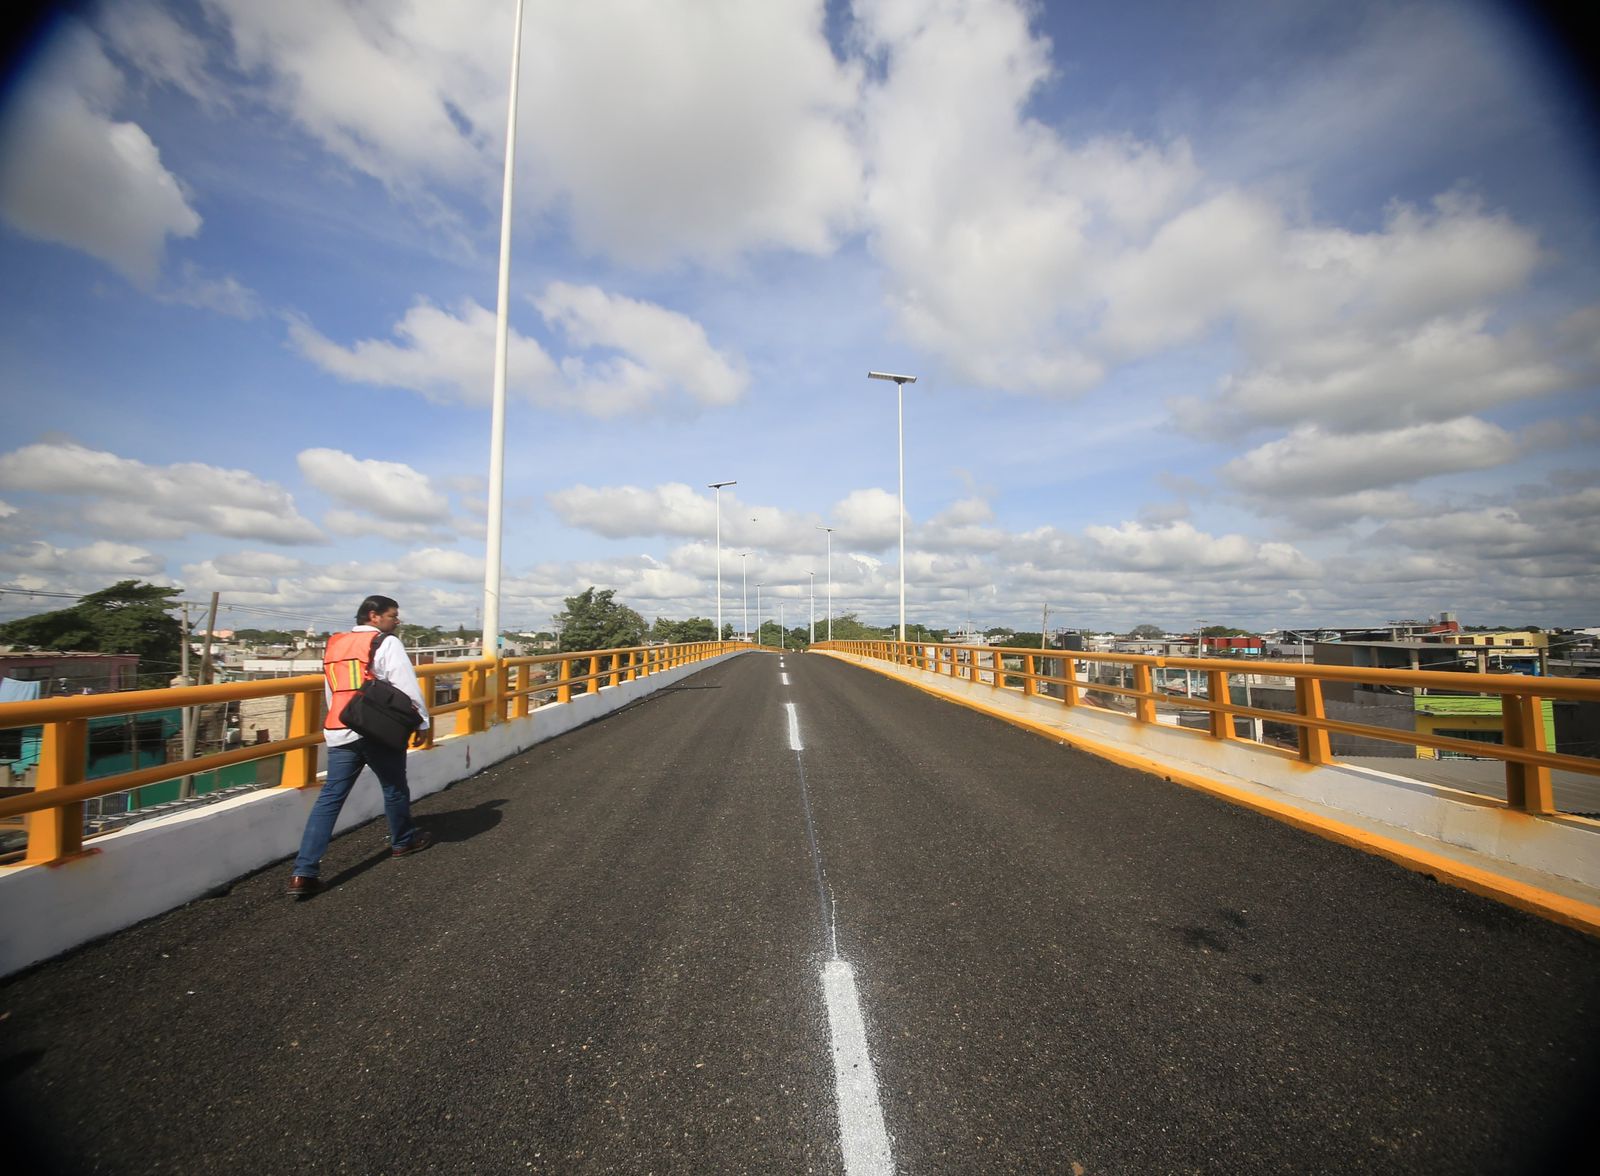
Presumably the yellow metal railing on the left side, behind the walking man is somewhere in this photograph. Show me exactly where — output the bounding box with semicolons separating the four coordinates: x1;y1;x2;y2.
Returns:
0;642;736;864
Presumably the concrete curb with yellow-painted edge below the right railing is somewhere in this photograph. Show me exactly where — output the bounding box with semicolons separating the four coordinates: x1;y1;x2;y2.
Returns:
816;650;1600;936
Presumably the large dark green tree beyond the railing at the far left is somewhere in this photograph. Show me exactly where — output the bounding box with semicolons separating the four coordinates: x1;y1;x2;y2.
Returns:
0;579;184;688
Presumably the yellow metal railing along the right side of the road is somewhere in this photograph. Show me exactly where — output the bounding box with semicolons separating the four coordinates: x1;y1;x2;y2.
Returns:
811;640;1600;813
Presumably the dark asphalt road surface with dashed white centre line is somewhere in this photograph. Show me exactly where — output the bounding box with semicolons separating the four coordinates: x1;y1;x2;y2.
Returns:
0;654;1600;1176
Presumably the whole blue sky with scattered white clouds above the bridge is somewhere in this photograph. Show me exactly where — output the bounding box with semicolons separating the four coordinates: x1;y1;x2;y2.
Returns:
0;0;1600;630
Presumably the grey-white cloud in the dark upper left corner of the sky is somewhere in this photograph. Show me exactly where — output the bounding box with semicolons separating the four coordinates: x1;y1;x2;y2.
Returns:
0;22;200;286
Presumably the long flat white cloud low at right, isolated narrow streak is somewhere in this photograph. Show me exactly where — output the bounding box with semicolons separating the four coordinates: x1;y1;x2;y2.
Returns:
1222;418;1520;499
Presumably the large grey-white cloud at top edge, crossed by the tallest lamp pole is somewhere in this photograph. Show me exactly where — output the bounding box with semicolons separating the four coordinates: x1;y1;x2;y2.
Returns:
195;0;861;264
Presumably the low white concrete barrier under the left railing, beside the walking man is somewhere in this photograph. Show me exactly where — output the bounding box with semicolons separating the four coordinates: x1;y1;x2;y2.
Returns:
0;650;746;976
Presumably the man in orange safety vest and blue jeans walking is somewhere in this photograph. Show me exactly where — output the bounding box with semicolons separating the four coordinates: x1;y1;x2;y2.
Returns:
290;595;434;899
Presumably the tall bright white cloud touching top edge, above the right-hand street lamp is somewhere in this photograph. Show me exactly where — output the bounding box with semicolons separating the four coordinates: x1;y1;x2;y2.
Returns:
856;0;1132;392
